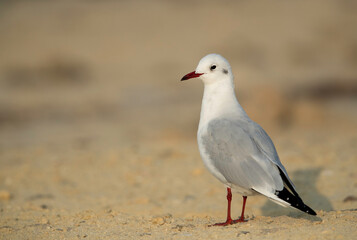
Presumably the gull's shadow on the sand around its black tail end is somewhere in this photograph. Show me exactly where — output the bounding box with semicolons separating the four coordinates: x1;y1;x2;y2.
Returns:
261;168;333;221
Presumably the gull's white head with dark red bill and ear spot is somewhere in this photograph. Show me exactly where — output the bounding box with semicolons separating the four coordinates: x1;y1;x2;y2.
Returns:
181;53;233;84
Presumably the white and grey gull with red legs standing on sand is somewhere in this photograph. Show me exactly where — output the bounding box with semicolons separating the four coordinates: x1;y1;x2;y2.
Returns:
181;53;316;226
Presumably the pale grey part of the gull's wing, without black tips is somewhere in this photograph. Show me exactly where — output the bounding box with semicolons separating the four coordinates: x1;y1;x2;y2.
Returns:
202;119;284;198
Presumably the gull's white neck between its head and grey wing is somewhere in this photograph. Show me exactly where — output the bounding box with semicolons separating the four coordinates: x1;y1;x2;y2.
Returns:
199;82;247;128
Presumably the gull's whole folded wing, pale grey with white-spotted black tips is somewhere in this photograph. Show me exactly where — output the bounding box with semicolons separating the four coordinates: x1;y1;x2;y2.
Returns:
202;119;314;214
